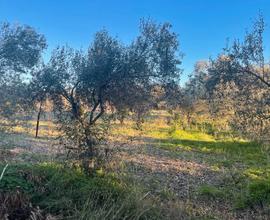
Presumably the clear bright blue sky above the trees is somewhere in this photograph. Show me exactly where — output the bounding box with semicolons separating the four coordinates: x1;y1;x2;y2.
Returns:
0;0;270;82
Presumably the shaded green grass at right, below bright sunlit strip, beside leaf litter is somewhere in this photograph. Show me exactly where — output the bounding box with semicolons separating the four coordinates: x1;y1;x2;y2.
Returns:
162;133;270;209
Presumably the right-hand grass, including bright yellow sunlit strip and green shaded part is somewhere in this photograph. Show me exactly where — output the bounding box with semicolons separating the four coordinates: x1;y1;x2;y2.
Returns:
112;117;270;213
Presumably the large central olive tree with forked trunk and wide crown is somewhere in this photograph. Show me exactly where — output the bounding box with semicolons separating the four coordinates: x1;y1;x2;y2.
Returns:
36;21;180;171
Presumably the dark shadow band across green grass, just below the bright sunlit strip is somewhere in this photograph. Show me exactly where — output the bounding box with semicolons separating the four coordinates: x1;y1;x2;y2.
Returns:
140;137;270;167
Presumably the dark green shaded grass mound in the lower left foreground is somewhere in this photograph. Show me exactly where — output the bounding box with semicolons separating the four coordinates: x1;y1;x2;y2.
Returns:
0;163;161;219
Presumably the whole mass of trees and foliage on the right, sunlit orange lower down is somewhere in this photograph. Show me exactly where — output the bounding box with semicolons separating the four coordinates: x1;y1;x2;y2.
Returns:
179;16;270;141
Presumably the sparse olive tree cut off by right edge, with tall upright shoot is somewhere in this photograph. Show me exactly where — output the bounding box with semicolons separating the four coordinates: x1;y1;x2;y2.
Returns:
207;16;270;139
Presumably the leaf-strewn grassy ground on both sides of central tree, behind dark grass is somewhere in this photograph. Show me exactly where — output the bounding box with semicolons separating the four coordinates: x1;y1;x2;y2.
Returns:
0;112;270;219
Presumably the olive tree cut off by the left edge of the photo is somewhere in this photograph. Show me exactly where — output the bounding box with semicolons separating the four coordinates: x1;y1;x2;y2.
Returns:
0;23;46;127
